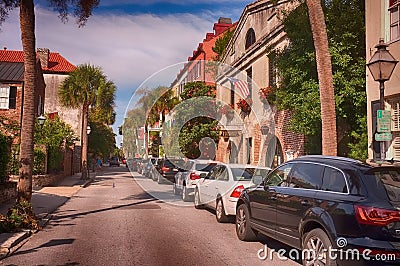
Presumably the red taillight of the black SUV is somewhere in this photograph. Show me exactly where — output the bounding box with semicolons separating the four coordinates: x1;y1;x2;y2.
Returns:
354;205;400;226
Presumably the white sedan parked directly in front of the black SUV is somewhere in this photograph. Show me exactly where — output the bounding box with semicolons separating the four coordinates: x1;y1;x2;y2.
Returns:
194;163;271;222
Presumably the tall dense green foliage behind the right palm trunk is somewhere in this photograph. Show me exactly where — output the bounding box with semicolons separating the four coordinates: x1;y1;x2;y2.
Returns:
275;0;366;156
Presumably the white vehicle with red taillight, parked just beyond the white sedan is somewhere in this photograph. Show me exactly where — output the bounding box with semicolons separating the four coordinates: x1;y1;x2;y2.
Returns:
173;160;217;201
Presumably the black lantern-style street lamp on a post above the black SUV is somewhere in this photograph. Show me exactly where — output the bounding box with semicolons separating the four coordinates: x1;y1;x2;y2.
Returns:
367;39;398;160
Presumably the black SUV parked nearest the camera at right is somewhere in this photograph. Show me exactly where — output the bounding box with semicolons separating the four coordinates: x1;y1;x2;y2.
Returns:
236;156;400;265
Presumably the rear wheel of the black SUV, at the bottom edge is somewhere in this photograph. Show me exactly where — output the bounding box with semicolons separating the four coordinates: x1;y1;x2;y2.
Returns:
302;228;337;266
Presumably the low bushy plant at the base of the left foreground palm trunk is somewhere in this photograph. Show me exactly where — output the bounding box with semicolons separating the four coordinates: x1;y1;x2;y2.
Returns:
0;201;40;233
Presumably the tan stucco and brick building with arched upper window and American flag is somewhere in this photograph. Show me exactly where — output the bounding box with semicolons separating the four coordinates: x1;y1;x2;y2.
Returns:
217;0;304;166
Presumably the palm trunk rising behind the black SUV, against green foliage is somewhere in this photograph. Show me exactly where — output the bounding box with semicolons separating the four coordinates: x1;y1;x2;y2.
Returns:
306;0;337;156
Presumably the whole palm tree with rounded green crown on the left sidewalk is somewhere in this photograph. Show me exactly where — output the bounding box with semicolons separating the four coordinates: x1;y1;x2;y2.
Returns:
59;64;115;179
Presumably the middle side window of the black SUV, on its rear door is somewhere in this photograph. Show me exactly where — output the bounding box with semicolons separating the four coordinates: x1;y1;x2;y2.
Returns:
289;163;324;189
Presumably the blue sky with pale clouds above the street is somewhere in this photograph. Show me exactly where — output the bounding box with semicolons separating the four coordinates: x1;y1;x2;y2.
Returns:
0;0;252;146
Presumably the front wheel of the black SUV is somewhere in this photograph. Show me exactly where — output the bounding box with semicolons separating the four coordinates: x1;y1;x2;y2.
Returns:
235;204;257;241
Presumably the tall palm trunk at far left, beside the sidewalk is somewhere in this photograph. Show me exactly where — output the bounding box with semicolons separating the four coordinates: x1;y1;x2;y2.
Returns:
17;0;37;202
